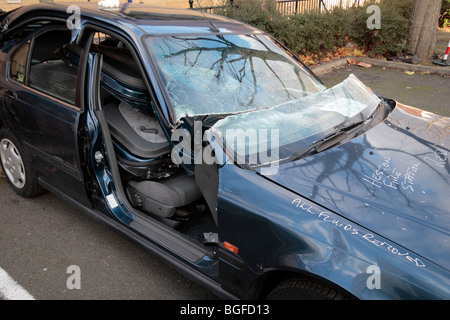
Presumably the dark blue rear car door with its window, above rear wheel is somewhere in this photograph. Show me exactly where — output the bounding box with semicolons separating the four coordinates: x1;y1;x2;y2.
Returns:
0;19;90;205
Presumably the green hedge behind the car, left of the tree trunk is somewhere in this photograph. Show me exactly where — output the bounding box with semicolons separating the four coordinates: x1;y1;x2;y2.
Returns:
224;0;414;55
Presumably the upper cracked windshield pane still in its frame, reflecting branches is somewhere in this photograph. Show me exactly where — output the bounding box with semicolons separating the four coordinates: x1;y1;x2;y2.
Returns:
146;34;324;121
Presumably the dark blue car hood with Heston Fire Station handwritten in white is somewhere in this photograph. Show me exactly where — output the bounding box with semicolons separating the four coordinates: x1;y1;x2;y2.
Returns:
267;104;450;270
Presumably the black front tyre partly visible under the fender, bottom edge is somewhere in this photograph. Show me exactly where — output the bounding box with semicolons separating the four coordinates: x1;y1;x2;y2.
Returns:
267;278;346;300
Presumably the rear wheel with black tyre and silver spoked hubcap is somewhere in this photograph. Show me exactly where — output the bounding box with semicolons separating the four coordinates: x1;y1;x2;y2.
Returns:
0;128;44;198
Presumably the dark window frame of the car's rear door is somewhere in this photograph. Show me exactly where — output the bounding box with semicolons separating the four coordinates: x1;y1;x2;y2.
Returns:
5;16;86;112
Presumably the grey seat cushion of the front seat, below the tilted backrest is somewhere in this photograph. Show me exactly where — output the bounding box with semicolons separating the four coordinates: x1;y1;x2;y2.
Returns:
127;175;202;218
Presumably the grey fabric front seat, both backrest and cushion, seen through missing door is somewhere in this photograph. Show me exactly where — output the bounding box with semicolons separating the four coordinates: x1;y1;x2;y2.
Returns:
103;102;202;218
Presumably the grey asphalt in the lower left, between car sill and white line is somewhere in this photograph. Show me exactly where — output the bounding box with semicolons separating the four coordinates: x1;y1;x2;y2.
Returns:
0;179;215;304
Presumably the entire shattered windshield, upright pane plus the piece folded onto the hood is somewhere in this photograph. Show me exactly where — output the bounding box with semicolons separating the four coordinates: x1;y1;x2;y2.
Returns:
146;35;381;171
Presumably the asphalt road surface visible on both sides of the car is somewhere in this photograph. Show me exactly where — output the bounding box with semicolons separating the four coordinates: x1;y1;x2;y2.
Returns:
0;66;450;300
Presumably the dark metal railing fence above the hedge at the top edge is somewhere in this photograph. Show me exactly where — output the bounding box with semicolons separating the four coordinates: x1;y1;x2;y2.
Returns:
189;0;376;15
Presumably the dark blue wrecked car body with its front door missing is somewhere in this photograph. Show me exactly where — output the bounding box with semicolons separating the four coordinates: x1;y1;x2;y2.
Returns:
0;3;450;299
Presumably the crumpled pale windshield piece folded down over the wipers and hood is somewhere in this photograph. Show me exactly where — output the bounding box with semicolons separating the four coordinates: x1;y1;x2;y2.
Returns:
210;74;381;164
